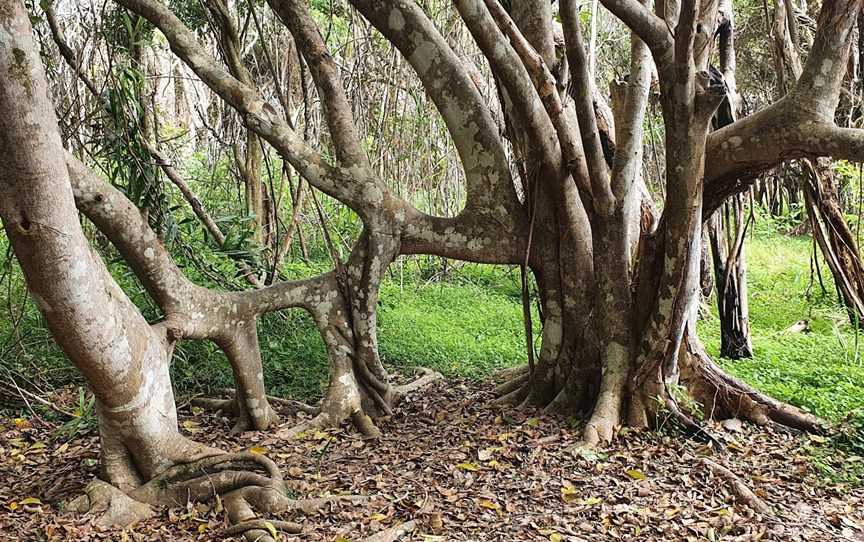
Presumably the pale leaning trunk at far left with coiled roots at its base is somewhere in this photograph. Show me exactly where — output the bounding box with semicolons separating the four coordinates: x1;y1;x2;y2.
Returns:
0;7;291;542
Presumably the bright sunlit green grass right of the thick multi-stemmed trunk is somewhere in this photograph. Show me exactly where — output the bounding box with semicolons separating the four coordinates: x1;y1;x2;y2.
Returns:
699;234;864;421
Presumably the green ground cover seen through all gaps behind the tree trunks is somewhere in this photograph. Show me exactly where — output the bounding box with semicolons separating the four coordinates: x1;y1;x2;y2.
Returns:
0;217;864;421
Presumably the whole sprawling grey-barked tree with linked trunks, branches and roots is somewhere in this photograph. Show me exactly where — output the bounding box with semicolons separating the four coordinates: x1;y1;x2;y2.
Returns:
0;0;864;536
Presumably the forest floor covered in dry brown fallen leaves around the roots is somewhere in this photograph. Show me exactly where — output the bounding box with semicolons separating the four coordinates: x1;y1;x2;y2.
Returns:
0;379;864;542
